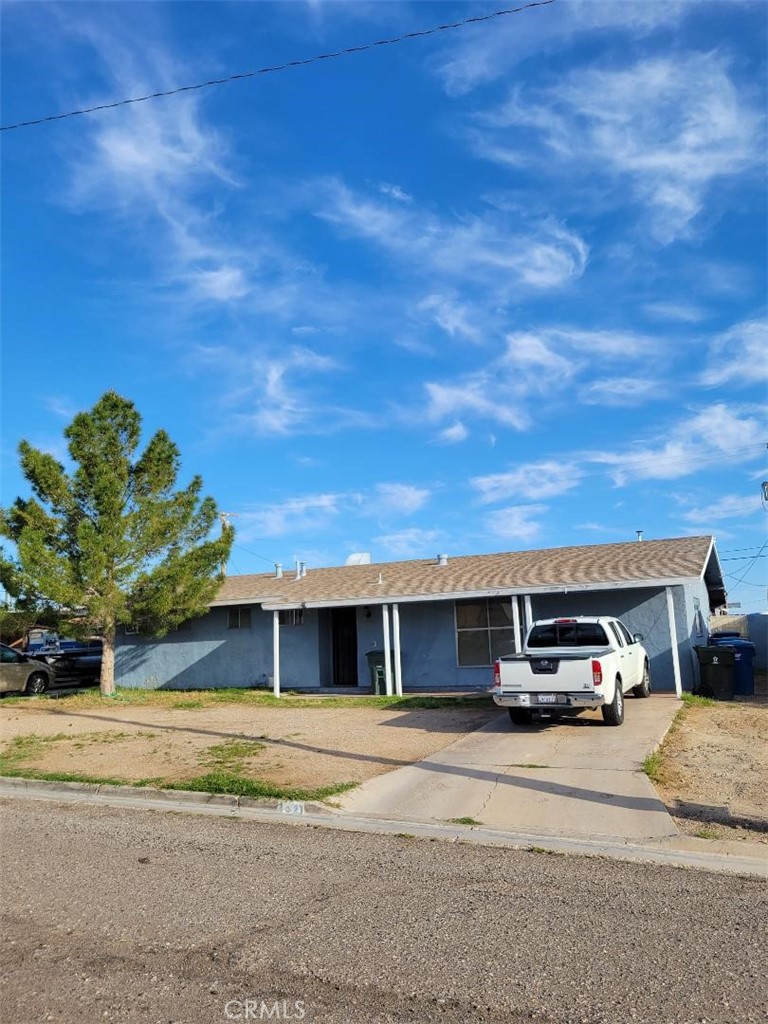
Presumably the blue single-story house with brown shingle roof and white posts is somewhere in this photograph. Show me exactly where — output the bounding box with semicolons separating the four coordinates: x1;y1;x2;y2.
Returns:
116;537;725;693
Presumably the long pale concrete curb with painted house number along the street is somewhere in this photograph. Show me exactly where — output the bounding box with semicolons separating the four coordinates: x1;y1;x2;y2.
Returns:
0;776;768;879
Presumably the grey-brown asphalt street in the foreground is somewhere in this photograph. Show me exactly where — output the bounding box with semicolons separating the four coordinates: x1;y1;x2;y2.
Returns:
0;798;768;1024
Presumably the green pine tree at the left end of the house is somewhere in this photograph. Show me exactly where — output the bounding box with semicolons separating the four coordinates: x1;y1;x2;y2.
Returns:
0;391;233;694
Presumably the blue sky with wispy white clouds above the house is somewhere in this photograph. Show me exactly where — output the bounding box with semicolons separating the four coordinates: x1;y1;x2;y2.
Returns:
2;0;768;610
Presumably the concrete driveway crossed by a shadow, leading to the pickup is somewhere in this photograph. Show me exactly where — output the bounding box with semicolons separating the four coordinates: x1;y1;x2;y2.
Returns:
340;694;680;841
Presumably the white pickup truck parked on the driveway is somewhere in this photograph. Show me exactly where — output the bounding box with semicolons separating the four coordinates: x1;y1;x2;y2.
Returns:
490;615;650;725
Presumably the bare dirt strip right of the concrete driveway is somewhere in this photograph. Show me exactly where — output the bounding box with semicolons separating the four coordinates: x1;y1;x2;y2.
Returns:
654;696;768;843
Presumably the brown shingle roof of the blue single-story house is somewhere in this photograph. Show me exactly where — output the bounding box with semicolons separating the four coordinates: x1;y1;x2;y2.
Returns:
213;537;713;605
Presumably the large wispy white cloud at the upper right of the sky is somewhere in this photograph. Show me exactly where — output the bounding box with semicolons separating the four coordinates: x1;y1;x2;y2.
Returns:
474;52;765;244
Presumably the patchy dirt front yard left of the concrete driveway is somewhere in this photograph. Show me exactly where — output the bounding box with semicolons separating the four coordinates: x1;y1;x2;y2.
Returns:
0;697;498;799
